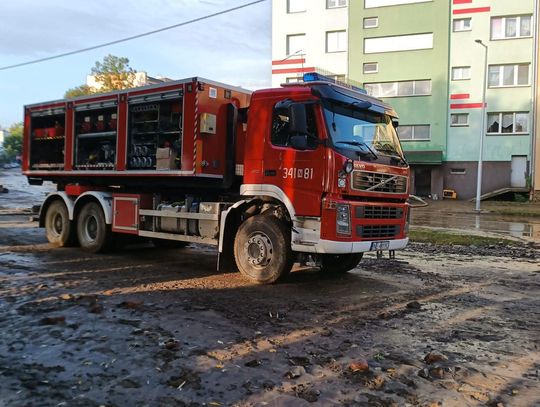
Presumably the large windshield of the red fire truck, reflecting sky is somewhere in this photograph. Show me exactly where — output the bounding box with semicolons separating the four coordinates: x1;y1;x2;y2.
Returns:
324;103;403;159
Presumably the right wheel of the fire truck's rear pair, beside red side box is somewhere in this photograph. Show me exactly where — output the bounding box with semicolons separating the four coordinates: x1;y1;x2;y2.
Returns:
77;202;112;253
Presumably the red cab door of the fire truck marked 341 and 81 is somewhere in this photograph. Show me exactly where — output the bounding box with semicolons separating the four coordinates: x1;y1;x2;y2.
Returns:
263;103;326;216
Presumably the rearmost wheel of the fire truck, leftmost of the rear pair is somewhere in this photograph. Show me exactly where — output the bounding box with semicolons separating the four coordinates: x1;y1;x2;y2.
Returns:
45;199;77;247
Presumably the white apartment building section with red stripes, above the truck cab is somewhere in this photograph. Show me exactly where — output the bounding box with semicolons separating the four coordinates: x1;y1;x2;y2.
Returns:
272;0;348;86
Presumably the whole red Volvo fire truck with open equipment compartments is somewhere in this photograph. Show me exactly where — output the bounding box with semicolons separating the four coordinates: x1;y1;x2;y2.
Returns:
23;73;409;283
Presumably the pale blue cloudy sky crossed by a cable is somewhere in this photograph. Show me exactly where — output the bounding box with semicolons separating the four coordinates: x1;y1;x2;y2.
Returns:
0;0;271;128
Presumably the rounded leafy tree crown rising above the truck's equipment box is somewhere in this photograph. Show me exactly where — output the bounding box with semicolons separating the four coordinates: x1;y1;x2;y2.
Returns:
92;54;135;92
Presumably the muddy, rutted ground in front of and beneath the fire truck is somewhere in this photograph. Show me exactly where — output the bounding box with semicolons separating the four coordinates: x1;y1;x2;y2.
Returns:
0;212;540;406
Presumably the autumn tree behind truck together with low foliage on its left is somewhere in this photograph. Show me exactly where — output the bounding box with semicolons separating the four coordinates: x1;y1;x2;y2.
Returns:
64;54;137;98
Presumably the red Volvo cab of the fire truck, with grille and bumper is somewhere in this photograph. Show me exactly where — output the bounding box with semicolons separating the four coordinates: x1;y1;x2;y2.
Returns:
234;74;409;280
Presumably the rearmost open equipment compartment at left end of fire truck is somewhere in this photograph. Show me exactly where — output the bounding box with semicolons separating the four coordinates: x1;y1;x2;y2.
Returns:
30;108;66;170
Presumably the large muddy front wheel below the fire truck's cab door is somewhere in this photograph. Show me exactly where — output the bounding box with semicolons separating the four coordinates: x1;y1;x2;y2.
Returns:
234;215;294;284
